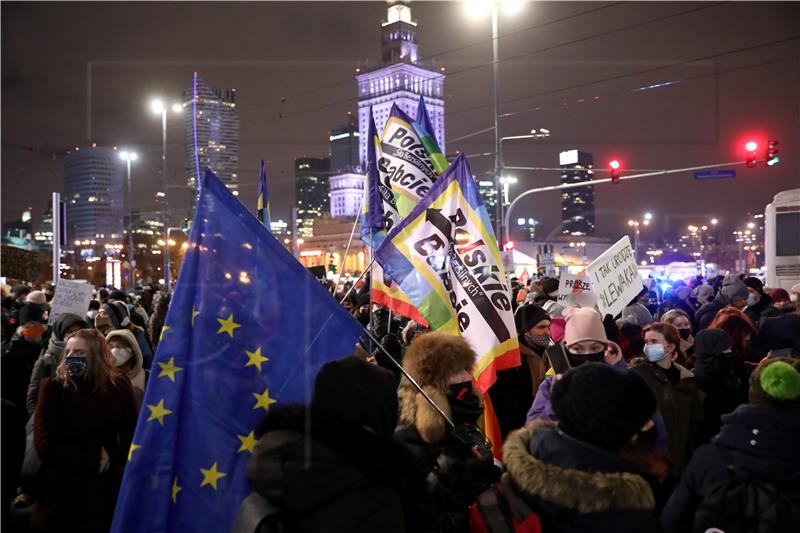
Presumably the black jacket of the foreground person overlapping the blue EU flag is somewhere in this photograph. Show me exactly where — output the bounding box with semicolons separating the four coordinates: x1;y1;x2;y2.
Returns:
246;406;418;533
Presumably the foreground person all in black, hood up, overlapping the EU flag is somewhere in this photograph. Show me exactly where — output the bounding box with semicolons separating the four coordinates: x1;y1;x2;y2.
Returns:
244;356;423;533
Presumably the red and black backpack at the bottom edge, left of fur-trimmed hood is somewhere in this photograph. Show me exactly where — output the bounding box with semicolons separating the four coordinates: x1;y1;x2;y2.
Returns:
469;474;542;533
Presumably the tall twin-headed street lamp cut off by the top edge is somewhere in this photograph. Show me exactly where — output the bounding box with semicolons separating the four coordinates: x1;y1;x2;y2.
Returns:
464;0;523;242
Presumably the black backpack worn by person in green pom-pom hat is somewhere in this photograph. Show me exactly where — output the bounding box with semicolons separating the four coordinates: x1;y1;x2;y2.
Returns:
692;465;800;533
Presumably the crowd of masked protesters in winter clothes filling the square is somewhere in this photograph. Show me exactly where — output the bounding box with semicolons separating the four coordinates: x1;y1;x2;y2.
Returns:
1;276;800;533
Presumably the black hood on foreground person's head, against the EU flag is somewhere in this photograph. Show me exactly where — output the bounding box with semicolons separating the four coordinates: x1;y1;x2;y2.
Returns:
311;355;398;436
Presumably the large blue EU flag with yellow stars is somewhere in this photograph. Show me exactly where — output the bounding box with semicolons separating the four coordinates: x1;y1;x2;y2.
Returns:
112;171;362;533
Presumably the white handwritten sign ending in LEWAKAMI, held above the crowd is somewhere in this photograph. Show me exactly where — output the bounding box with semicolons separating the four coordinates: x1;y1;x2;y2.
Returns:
586;235;643;316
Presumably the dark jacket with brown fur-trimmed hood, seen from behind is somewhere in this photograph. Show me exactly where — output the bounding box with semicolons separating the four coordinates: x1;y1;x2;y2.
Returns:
503;420;659;533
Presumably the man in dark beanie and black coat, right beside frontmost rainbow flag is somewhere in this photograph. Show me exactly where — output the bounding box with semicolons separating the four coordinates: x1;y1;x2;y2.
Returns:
489;303;550;439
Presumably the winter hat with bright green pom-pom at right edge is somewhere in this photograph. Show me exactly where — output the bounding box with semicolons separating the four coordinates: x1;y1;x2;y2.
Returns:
750;358;800;407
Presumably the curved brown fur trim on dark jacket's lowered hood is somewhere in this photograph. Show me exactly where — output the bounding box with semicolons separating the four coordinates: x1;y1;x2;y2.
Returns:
503;420;655;514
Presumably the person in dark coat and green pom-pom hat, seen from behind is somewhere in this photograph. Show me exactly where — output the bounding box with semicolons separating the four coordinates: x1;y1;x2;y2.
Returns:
661;359;800;533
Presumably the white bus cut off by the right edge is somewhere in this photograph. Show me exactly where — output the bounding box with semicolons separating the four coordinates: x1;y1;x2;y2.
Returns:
764;189;800;291
